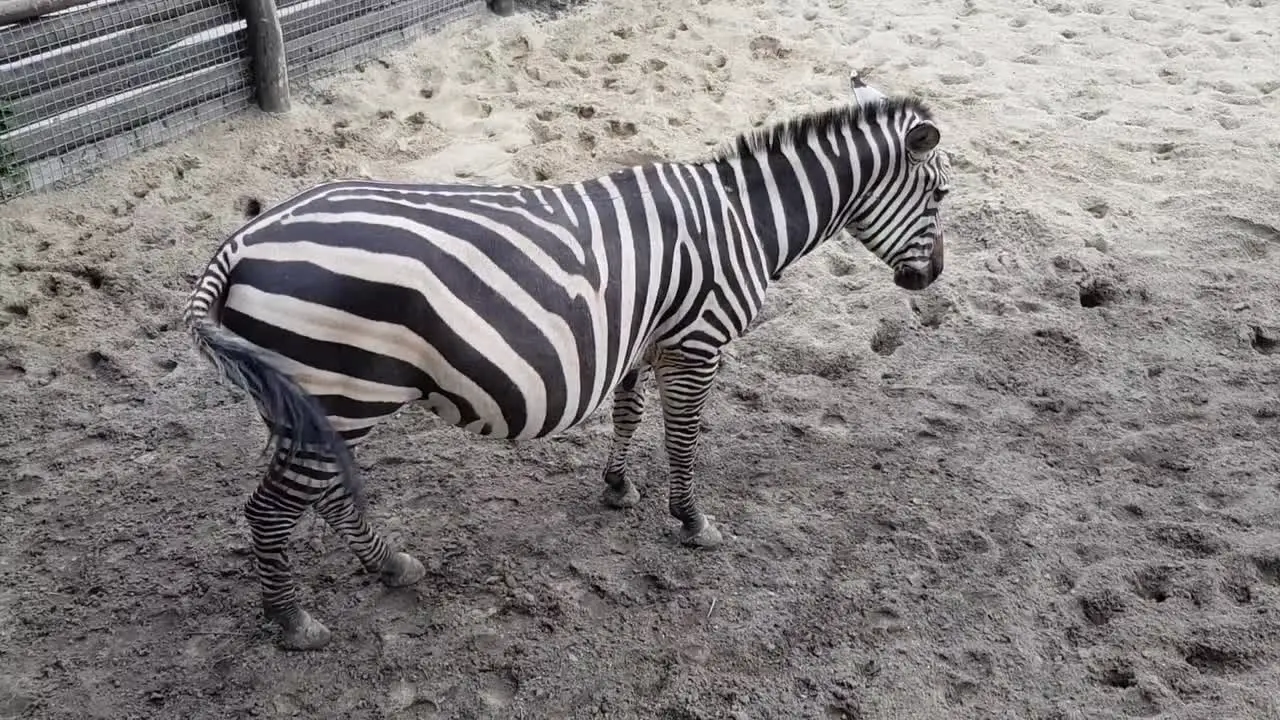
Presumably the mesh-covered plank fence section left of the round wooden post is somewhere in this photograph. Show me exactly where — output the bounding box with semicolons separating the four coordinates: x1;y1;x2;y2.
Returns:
0;0;252;200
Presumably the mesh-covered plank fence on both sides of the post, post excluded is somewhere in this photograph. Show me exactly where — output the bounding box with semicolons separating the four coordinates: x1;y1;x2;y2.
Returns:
0;0;485;202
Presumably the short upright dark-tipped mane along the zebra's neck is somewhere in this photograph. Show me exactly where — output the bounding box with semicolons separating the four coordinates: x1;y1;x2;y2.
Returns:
713;95;933;160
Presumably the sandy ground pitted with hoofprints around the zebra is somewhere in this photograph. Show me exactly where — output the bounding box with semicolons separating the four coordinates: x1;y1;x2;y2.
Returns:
0;0;1280;720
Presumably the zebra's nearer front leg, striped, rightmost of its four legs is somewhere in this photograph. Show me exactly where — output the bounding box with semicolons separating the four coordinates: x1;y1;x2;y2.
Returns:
655;350;723;547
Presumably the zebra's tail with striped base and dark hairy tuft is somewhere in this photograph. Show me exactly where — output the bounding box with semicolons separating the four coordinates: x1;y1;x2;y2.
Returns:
186;271;365;509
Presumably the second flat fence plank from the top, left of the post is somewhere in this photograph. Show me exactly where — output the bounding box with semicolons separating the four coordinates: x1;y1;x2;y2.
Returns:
0;5;236;102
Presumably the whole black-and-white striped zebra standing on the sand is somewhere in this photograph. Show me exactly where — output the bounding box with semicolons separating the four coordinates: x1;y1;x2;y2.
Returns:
183;73;951;650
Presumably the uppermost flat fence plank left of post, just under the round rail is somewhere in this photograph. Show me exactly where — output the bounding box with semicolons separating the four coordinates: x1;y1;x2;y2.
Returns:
0;0;225;63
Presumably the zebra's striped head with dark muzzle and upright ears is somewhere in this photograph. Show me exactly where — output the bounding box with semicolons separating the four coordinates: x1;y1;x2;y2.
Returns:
846;70;951;290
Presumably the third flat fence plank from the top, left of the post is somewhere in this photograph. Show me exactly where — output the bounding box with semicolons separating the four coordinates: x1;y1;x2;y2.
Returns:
4;31;244;129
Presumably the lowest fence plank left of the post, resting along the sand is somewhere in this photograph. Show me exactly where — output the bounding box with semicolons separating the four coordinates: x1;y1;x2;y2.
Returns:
0;83;253;199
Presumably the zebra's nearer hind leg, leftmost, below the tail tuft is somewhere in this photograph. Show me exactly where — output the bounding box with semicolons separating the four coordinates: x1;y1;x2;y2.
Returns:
244;448;338;650
